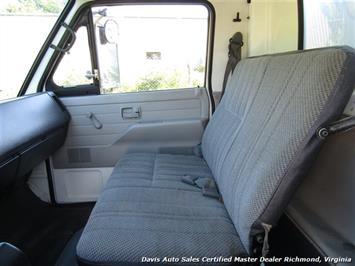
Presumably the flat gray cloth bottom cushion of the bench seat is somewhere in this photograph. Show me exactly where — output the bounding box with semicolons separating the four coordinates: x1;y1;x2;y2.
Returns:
77;154;246;265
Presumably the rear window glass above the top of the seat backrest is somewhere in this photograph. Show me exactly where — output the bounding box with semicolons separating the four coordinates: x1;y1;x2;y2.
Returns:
304;0;355;49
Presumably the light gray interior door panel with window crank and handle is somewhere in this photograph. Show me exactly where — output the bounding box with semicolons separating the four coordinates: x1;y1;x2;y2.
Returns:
52;88;209;202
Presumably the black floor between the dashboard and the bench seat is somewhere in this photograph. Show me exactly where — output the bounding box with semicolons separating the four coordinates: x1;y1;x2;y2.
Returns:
0;186;93;266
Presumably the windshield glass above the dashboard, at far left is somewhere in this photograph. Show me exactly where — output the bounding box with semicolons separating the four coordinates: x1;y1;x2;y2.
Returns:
0;0;67;100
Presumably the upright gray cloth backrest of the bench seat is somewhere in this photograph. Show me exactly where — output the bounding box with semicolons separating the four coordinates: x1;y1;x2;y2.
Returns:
202;47;355;252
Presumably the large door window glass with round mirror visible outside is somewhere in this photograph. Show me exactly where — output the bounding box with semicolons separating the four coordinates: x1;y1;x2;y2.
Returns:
92;5;208;93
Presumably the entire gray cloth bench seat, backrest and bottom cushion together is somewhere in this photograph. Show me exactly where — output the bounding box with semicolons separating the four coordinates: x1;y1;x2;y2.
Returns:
77;47;355;265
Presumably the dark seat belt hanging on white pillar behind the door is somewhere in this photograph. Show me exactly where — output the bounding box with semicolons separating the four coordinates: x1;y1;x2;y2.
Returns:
221;32;244;97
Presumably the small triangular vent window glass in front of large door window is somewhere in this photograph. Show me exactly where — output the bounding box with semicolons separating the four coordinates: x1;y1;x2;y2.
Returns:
53;26;93;87
